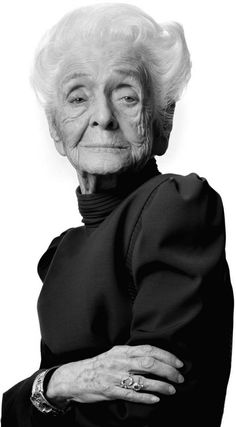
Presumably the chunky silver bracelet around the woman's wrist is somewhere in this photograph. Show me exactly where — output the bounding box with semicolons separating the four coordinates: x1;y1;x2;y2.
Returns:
30;367;70;415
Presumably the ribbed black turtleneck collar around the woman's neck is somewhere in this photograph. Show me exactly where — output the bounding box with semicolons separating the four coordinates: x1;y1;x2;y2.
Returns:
76;157;160;229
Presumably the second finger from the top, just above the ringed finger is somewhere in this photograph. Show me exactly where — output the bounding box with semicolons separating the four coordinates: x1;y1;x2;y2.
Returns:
125;356;184;383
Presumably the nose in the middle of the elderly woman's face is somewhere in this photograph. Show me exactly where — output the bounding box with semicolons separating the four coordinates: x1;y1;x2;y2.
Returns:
90;96;119;130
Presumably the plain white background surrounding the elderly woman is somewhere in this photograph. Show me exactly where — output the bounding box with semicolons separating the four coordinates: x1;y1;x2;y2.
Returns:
0;0;236;427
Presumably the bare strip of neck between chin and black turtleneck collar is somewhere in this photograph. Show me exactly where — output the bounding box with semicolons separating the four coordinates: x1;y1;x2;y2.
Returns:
77;172;119;194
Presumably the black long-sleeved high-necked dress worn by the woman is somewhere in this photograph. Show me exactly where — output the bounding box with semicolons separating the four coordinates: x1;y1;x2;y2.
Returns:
2;159;233;427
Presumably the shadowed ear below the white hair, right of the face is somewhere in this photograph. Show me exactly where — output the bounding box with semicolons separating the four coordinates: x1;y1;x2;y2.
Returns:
153;102;175;156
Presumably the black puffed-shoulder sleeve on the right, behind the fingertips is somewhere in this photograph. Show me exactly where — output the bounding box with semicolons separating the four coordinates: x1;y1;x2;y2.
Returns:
121;174;233;427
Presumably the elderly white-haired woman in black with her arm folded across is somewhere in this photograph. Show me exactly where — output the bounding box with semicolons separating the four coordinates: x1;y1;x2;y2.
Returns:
2;4;233;427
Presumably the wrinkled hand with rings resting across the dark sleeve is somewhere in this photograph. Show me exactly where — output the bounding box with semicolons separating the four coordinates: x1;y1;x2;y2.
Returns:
46;345;184;406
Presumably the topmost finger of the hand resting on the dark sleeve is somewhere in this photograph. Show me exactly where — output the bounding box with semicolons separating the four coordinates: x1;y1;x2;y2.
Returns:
128;344;184;368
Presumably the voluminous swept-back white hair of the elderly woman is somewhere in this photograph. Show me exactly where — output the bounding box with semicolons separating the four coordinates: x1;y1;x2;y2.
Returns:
31;3;191;122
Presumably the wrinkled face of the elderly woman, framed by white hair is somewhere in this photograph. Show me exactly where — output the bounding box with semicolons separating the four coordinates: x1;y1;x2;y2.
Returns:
49;38;155;175
